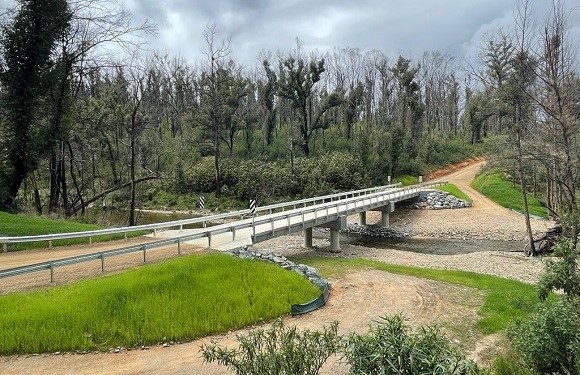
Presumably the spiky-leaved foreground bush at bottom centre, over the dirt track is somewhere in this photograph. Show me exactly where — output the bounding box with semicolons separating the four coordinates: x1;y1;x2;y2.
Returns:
200;319;340;375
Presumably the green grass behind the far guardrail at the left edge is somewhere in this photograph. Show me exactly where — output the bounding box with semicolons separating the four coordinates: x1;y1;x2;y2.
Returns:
0;211;144;251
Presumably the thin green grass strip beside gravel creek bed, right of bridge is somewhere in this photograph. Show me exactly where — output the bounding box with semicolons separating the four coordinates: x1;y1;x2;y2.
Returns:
293;257;539;334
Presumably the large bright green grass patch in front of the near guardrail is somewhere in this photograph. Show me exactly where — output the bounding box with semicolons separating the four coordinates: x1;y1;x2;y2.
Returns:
0;253;320;355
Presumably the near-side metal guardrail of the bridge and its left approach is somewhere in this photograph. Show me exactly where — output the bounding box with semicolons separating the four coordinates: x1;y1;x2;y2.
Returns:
0;182;444;282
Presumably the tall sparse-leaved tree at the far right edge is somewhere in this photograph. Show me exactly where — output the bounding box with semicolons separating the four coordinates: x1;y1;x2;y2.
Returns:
531;1;580;244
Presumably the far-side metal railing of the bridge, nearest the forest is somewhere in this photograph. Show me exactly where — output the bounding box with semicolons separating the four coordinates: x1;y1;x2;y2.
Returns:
0;183;400;252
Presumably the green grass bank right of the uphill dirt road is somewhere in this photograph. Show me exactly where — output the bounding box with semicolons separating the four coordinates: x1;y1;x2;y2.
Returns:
471;170;548;218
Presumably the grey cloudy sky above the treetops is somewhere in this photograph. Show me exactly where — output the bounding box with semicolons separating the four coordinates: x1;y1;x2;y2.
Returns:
0;0;580;66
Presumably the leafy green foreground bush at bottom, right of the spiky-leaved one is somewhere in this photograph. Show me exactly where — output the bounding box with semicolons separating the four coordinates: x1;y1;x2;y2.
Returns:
345;314;480;375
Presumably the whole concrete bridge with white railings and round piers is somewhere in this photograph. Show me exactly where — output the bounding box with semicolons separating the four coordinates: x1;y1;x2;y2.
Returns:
0;183;443;282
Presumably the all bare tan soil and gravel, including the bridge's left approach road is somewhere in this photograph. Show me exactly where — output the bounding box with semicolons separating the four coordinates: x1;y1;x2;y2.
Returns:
0;159;550;375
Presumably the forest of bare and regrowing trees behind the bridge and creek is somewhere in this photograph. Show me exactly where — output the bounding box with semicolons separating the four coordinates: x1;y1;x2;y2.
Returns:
0;0;580;238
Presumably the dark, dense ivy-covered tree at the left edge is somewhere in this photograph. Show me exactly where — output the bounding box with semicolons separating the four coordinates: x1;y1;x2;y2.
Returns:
0;0;71;210
